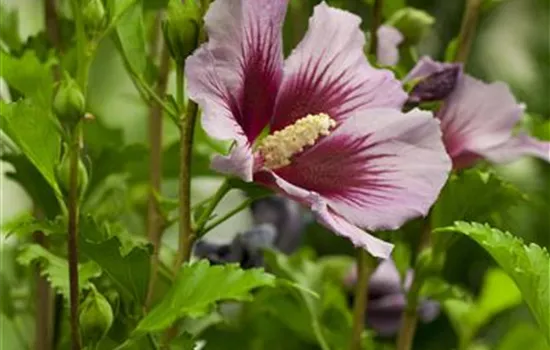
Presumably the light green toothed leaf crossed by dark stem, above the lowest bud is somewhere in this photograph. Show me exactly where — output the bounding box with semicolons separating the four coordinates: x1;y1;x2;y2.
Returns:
17;244;101;299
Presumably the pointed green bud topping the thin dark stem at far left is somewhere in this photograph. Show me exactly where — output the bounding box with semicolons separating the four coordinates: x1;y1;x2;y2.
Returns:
53;74;86;124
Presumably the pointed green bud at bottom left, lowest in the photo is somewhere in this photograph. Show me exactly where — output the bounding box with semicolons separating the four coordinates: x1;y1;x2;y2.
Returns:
79;286;113;345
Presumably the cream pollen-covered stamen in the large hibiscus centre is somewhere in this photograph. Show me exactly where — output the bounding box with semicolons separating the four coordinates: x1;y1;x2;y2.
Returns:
258;113;336;169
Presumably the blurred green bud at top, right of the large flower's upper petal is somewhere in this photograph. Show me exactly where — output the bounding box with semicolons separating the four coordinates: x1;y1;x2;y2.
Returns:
386;7;435;45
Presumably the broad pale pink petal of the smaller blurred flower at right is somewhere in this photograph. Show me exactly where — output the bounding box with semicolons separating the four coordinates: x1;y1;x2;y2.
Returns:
436;75;523;167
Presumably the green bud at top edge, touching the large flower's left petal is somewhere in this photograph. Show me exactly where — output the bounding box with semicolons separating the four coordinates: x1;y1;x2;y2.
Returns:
162;0;201;64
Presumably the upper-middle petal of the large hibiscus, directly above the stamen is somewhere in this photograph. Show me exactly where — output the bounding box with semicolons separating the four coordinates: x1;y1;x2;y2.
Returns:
272;2;406;130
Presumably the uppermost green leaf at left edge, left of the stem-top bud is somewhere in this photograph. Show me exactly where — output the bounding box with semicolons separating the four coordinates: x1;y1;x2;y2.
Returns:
0;50;54;106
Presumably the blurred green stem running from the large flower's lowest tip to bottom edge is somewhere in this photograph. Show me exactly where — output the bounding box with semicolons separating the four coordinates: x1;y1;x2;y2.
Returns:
350;249;377;350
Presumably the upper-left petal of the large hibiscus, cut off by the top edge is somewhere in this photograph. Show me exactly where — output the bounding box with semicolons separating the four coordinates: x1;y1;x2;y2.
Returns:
186;0;288;143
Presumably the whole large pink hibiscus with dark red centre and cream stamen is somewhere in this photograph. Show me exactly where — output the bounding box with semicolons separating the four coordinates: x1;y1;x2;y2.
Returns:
185;0;451;258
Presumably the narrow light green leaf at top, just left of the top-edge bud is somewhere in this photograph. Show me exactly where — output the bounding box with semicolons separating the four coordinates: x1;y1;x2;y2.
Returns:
115;2;147;77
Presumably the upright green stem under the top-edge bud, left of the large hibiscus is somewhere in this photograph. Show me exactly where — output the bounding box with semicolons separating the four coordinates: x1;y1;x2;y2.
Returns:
174;65;199;274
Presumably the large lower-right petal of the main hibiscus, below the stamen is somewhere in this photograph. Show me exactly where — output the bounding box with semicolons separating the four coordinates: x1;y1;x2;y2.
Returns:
275;109;451;230
